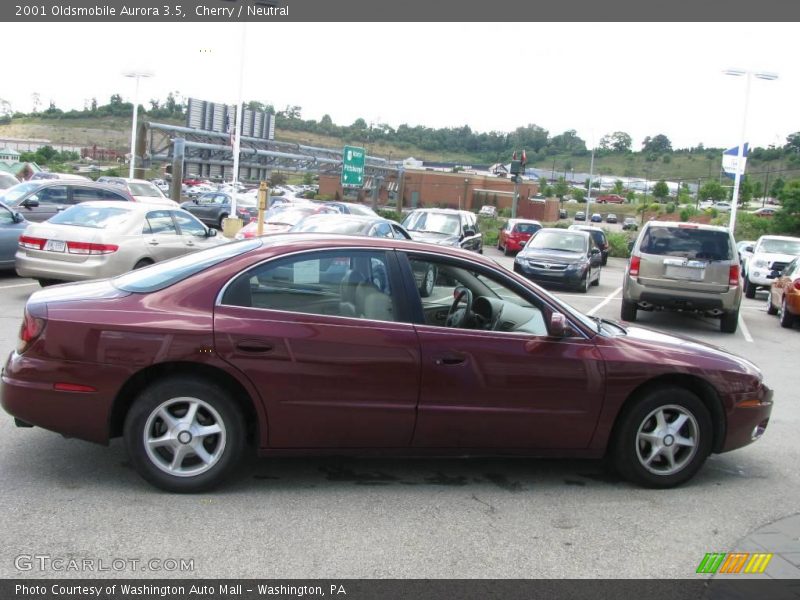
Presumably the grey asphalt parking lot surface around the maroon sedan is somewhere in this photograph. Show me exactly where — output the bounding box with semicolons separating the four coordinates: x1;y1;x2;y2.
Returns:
0;249;800;578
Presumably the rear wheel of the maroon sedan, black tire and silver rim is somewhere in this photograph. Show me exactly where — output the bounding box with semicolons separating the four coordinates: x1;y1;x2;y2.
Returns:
124;375;245;493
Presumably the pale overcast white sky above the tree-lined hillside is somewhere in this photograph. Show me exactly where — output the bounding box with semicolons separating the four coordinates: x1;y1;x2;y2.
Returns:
0;22;800;150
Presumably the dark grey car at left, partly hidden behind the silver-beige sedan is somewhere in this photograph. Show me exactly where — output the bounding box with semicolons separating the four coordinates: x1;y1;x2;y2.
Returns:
0;179;134;223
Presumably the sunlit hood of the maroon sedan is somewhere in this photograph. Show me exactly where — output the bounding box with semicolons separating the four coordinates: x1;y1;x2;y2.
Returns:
618;323;761;378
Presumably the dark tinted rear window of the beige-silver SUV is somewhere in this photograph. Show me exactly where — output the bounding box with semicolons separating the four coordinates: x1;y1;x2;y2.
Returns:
639;226;732;260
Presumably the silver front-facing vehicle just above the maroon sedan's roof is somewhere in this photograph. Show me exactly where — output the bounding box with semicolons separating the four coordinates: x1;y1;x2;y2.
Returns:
403;208;483;254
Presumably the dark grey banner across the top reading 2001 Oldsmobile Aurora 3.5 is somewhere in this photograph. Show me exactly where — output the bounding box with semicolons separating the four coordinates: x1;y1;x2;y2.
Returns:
0;0;800;23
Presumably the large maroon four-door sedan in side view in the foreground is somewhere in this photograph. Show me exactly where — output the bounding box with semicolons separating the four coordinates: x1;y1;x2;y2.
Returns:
2;234;772;492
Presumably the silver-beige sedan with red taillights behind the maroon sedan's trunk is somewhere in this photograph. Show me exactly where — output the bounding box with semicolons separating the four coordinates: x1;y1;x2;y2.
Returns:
16;202;226;285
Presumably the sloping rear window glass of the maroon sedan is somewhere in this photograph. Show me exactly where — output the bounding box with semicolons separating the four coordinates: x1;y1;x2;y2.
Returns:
111;239;263;293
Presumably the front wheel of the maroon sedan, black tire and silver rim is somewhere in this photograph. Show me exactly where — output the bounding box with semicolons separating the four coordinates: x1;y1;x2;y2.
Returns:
611;386;713;488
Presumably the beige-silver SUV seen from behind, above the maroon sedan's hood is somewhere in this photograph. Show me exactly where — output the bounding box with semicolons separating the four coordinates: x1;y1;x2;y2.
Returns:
620;221;742;333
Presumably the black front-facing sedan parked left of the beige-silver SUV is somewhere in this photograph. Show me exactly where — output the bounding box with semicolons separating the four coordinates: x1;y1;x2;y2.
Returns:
514;228;603;293
